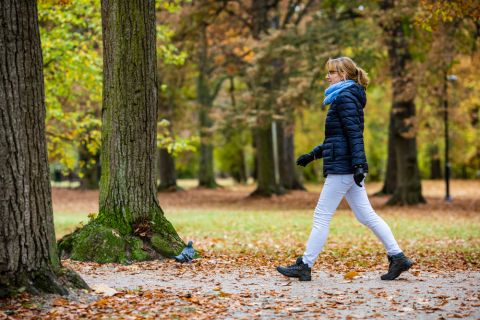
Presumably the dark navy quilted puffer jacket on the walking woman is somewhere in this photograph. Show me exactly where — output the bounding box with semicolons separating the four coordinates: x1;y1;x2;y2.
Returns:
312;84;368;176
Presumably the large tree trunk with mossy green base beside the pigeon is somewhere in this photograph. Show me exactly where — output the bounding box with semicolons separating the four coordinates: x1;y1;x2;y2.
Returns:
56;0;184;262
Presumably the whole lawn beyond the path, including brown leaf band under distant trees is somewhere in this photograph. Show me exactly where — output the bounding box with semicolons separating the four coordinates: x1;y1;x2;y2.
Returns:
53;180;480;270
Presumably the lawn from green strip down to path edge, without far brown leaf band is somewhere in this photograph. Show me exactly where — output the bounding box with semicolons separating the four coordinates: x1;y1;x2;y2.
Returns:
55;208;480;268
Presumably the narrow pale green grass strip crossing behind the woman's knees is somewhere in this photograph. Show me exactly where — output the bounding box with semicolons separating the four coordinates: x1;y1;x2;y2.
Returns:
54;209;480;240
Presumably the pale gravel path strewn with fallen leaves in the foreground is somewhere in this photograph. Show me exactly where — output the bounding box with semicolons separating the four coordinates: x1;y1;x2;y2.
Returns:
63;258;480;319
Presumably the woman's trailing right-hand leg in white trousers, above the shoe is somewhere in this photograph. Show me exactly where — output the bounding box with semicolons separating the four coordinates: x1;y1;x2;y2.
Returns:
342;175;402;256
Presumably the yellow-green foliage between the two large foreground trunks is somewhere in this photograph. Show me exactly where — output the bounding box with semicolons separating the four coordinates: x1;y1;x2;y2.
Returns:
38;0;102;189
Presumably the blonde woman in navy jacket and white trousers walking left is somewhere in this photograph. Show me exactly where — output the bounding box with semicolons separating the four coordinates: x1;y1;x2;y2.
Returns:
277;57;412;281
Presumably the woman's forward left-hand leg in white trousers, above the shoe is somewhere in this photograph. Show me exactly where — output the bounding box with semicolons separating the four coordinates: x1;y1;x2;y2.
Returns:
303;174;348;268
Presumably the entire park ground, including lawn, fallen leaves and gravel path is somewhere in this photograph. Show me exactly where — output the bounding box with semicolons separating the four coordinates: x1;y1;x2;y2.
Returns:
0;181;480;319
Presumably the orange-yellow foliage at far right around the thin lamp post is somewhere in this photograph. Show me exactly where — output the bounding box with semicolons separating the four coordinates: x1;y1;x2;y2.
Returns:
414;0;480;178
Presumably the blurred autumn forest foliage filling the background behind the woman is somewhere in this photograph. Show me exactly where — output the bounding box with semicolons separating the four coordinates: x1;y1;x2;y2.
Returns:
39;0;480;193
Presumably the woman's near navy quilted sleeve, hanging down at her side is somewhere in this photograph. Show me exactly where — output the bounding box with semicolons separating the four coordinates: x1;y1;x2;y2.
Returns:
335;95;367;167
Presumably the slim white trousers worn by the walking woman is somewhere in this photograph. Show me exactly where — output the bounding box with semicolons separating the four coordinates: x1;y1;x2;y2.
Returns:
303;174;402;267
